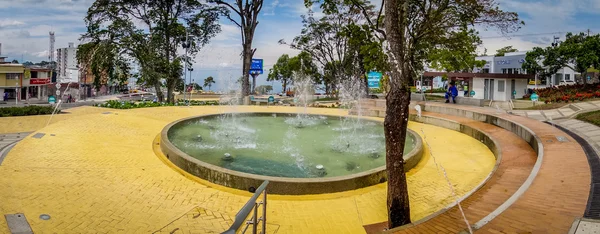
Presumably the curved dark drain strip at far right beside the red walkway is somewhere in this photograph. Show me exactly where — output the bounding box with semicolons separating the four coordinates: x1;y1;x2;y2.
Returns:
546;122;600;219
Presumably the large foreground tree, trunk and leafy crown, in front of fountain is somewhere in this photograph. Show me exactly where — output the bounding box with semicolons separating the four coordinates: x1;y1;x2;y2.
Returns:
305;0;520;228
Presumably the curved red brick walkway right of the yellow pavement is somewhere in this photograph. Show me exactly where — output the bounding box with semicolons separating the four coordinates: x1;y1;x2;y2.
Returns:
365;103;590;233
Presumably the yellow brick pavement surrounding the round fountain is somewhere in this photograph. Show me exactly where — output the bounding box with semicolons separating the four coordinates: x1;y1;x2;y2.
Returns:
0;107;494;233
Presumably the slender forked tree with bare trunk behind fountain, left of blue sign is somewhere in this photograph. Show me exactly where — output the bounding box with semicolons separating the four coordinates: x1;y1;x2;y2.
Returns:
209;0;263;96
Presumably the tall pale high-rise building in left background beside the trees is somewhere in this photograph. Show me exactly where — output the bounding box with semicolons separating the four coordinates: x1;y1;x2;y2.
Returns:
56;42;79;83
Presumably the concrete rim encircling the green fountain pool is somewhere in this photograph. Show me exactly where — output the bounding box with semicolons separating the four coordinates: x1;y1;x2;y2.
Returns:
160;112;423;195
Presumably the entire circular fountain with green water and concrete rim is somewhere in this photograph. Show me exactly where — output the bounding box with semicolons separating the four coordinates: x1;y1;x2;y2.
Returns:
161;113;422;194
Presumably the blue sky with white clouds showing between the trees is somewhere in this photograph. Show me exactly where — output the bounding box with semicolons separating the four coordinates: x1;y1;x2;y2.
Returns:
0;0;600;91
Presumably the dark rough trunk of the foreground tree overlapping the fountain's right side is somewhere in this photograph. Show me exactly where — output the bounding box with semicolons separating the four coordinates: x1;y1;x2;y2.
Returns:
384;0;412;228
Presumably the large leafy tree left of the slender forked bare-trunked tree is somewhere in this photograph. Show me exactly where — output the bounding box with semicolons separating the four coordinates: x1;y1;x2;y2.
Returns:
83;0;224;102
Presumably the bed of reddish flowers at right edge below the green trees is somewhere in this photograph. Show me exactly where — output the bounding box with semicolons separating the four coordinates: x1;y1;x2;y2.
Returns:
523;84;600;103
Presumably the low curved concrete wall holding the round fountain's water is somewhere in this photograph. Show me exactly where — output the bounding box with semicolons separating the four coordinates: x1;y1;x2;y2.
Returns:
160;113;423;195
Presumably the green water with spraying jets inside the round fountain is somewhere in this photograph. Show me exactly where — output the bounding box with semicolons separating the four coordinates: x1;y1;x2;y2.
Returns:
168;113;414;178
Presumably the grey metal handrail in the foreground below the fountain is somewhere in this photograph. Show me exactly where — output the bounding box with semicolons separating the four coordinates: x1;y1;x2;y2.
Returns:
222;180;269;234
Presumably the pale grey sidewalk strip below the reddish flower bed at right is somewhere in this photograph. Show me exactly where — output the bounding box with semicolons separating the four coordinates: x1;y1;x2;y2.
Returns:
509;101;600;121
